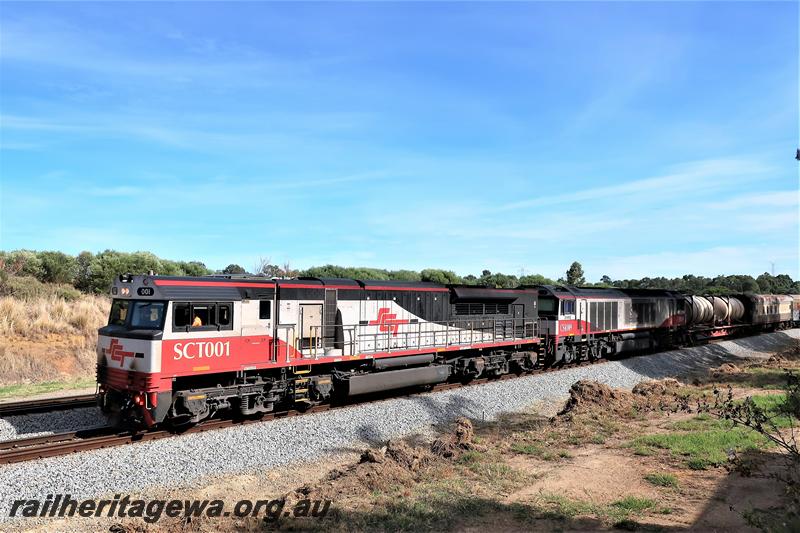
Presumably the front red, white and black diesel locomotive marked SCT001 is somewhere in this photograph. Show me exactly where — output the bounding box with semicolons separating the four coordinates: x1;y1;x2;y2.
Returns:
97;275;539;426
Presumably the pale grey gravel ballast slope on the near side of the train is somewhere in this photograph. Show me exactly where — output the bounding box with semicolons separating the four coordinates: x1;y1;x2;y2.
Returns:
0;330;800;517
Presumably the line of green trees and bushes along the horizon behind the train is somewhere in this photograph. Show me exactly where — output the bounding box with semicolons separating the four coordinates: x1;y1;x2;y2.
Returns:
0;250;800;295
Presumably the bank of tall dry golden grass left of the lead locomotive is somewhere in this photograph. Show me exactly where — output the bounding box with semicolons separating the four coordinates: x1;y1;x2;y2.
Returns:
0;296;110;385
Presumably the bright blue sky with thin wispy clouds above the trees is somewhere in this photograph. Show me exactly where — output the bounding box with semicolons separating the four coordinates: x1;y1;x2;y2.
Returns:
0;2;800;280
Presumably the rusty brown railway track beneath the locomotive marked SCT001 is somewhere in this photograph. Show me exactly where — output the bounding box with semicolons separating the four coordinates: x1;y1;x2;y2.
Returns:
0;359;608;464
